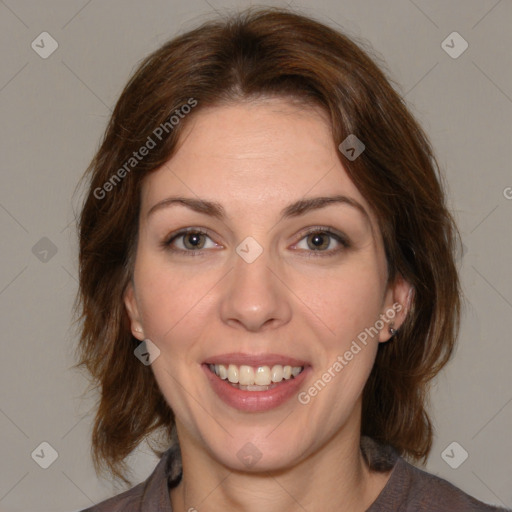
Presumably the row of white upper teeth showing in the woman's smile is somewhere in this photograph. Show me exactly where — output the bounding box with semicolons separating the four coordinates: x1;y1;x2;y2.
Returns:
210;364;304;391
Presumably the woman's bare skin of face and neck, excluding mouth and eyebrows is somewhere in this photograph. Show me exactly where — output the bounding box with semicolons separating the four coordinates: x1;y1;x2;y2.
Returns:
124;98;410;512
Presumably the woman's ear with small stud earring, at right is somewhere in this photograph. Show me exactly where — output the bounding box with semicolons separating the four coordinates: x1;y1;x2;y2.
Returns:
379;275;414;343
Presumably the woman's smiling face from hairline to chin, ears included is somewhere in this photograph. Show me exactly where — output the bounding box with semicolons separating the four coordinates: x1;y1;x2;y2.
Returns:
125;99;408;470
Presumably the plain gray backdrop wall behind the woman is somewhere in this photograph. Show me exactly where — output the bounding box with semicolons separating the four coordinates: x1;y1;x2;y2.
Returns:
0;0;512;512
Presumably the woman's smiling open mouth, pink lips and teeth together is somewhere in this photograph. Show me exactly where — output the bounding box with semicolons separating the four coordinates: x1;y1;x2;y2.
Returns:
201;354;311;412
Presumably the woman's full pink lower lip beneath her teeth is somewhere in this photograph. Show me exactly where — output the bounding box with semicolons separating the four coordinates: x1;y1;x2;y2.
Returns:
202;364;311;412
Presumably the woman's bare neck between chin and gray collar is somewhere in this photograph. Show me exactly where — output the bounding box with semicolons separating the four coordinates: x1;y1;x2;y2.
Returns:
171;418;391;512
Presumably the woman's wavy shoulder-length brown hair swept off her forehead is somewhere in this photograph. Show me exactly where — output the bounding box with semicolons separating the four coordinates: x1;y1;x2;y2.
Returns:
75;8;461;483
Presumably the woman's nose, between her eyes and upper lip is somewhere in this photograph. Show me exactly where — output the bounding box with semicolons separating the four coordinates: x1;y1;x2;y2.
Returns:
220;244;292;332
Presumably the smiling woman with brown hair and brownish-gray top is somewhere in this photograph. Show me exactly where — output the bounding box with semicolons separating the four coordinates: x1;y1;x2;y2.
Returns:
74;5;510;512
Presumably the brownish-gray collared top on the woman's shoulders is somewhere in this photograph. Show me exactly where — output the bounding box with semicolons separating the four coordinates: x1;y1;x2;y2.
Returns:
82;437;512;512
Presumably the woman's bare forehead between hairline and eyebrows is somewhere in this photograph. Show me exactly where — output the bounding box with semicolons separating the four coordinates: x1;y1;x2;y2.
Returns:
138;98;374;228
